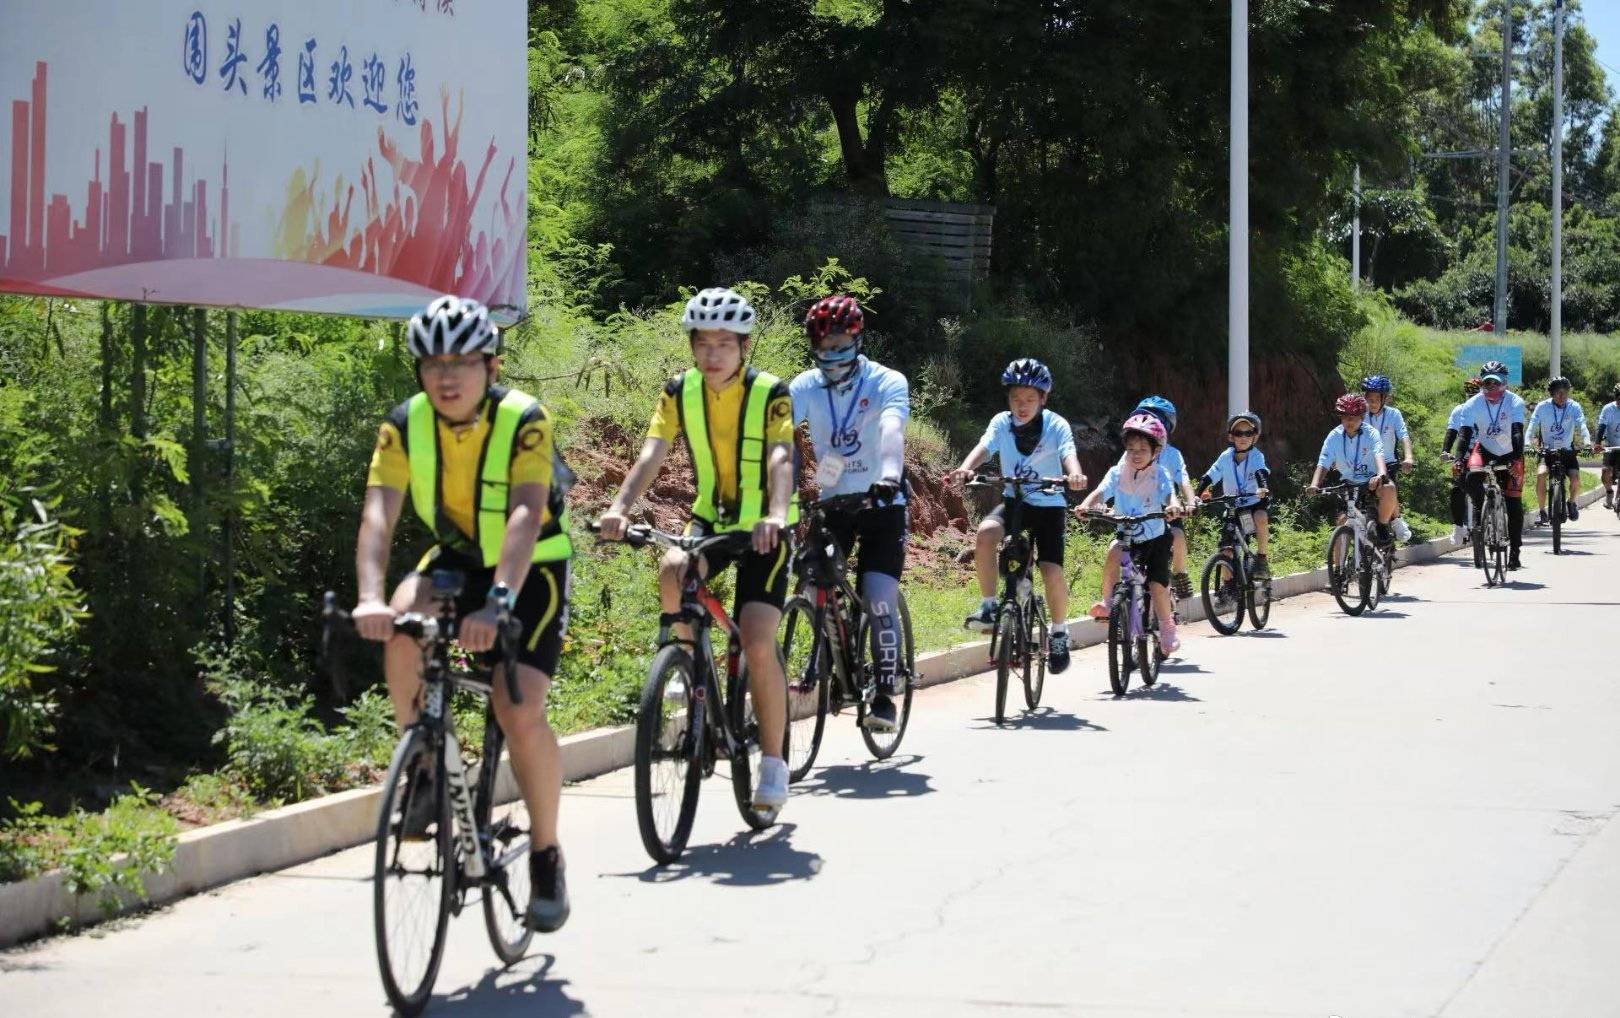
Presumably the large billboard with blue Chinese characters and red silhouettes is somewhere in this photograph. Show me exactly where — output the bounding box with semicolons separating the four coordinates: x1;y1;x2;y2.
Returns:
0;0;528;323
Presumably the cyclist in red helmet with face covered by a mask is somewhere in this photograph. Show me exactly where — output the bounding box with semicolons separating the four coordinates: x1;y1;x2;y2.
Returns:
787;297;910;731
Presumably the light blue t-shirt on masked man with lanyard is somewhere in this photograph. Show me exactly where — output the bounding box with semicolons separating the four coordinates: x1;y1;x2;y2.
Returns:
787;357;910;504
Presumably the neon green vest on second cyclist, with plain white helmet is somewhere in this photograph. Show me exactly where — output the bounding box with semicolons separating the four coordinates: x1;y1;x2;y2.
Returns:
677;368;799;533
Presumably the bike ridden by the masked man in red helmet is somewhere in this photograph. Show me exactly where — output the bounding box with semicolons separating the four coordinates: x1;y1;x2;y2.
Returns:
782;491;917;781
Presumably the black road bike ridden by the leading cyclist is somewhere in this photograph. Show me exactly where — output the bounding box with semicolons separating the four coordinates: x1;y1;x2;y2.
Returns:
321;569;535;1015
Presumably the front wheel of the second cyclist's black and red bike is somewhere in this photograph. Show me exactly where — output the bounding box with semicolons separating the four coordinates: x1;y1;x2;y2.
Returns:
635;644;705;866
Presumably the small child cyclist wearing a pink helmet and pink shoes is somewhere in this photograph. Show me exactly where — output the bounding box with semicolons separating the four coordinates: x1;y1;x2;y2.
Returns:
1074;412;1183;657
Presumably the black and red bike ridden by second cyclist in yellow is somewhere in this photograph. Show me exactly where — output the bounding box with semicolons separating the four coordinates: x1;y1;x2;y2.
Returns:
590;522;792;866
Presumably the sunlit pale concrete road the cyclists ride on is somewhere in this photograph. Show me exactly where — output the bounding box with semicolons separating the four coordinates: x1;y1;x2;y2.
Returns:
0;521;1620;1018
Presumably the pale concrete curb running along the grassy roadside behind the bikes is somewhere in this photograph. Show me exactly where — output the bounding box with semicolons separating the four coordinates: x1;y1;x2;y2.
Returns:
0;488;1602;947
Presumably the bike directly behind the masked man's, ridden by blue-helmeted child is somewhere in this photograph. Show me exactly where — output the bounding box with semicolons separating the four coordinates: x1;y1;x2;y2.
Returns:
966;473;1068;725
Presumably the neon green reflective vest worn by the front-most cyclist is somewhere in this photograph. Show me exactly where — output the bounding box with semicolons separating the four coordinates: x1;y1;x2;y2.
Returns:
403;389;573;567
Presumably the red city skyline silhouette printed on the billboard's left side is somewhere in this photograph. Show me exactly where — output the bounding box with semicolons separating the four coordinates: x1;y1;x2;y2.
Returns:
0;60;240;280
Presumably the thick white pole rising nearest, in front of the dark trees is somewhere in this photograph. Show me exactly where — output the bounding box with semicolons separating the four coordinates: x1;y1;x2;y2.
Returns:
1226;0;1249;413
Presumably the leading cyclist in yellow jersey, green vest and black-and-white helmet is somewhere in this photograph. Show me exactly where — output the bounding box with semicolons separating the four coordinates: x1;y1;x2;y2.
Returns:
353;297;573;932
